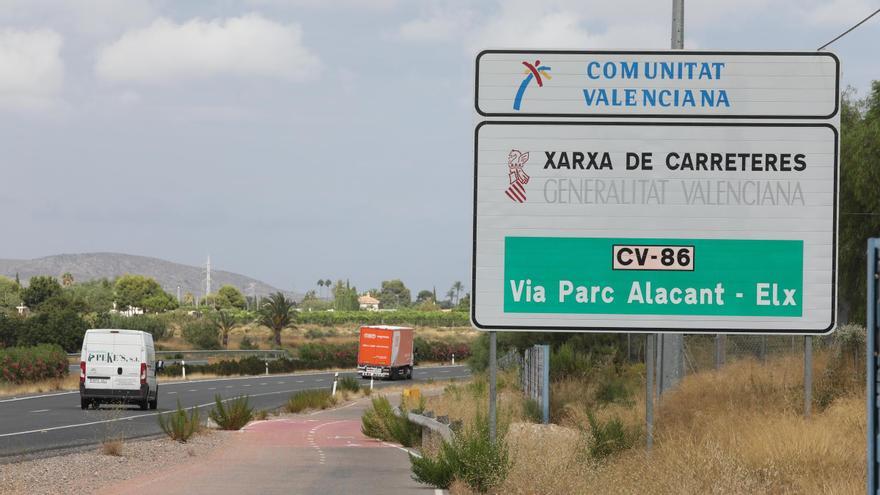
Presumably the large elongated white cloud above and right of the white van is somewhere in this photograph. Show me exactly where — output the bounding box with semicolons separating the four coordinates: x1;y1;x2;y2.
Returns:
95;14;321;84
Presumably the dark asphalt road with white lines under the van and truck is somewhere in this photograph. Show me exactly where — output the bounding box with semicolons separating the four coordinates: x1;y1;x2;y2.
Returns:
0;366;470;462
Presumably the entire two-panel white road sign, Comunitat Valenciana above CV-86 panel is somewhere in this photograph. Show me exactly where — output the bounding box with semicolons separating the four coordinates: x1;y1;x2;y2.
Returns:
471;50;839;335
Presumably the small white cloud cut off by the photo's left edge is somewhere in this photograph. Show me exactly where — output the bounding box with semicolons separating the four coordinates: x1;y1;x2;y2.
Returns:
0;29;64;108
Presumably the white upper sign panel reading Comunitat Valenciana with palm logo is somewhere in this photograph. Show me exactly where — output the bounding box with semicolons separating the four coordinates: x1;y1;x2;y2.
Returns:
475;50;840;119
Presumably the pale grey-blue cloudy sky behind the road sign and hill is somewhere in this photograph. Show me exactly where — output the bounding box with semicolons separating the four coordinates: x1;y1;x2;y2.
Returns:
0;0;880;295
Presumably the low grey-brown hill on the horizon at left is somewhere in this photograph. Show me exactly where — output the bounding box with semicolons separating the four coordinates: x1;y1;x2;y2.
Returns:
0;253;279;295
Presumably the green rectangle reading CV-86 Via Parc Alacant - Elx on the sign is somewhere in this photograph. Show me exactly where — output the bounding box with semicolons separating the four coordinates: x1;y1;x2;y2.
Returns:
504;237;804;317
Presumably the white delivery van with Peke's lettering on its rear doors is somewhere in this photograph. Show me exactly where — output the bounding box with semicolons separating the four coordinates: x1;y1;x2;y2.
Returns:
79;329;162;409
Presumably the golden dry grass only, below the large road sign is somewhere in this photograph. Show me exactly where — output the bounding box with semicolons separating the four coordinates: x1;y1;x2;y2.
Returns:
429;355;867;494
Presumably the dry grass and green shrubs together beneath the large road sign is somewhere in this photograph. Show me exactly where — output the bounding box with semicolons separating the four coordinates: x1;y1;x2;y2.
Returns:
402;325;866;494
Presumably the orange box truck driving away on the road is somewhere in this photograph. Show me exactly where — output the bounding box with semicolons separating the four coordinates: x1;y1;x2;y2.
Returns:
358;325;413;380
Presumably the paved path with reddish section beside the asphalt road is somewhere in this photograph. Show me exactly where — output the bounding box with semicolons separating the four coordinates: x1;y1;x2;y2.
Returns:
100;399;435;495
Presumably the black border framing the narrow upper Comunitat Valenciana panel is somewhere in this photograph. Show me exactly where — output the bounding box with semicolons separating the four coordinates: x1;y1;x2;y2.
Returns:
474;50;840;120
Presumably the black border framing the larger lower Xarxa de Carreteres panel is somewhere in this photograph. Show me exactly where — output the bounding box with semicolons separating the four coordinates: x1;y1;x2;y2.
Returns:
470;120;840;335
